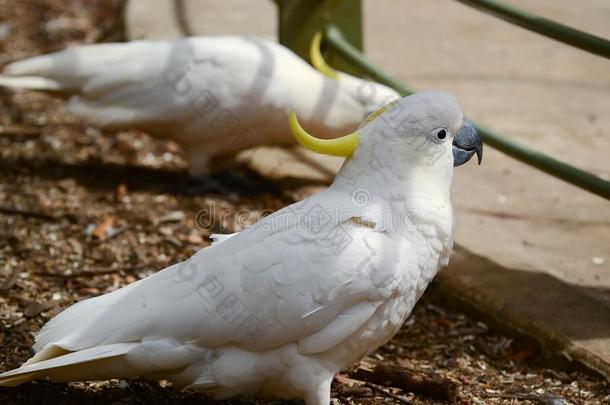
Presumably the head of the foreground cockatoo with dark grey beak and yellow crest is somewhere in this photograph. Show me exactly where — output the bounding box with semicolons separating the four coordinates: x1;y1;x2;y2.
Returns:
290;91;483;187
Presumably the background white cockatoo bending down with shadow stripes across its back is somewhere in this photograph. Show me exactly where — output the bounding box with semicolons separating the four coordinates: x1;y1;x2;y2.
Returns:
0;34;400;177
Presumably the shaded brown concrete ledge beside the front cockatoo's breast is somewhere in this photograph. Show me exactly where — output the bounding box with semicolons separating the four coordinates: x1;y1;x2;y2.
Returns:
434;246;610;380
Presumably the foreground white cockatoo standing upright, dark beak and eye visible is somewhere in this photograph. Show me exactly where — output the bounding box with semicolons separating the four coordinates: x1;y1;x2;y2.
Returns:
0;91;482;405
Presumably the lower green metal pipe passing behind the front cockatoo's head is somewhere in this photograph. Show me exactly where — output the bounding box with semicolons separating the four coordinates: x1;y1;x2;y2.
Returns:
325;25;610;199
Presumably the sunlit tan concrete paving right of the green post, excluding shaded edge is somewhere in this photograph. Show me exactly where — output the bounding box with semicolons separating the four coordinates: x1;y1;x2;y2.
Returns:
365;0;610;304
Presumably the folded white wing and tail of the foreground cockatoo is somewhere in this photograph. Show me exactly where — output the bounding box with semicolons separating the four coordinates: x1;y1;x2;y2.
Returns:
0;191;419;395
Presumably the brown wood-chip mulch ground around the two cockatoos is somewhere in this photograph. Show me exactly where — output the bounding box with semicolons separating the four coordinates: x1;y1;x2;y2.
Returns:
0;0;610;405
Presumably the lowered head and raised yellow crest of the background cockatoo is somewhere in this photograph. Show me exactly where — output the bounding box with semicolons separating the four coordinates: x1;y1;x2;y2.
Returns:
309;32;400;119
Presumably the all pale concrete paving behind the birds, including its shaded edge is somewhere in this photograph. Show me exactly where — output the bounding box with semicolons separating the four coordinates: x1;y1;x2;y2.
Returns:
127;0;610;376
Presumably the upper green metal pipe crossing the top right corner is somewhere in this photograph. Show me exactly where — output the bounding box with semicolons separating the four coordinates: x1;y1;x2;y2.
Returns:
457;0;610;59
